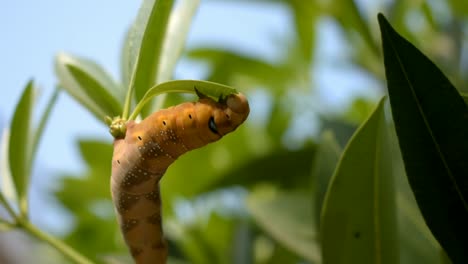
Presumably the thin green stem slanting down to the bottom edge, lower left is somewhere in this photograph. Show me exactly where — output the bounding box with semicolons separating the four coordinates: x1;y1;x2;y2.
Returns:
18;220;93;264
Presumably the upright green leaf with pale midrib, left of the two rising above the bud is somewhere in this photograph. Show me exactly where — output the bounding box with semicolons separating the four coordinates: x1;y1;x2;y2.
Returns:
122;0;174;119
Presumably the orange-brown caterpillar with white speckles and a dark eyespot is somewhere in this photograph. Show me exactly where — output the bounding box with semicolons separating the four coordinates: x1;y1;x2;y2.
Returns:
111;93;250;264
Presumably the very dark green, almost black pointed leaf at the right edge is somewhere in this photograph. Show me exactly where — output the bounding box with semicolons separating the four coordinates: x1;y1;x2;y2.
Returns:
378;14;468;263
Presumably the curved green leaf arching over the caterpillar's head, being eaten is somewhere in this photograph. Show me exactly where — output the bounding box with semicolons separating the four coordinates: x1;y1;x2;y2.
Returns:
129;80;237;120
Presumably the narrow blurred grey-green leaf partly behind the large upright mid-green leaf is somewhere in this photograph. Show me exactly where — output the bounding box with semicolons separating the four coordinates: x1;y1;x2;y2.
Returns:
312;130;341;226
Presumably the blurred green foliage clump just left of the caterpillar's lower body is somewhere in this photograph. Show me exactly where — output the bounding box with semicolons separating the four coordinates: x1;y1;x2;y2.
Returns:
55;140;122;261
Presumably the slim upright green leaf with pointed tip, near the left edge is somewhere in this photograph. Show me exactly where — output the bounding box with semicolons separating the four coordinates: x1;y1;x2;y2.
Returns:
8;80;35;215
